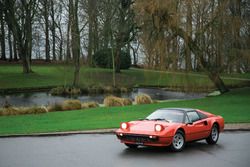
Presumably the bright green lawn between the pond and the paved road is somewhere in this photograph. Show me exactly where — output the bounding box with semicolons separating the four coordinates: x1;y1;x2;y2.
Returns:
0;88;250;135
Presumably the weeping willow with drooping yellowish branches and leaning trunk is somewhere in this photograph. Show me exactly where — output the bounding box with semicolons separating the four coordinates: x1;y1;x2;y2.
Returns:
135;0;250;93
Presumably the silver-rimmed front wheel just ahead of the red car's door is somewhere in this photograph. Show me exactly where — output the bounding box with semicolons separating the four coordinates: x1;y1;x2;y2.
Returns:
170;130;186;152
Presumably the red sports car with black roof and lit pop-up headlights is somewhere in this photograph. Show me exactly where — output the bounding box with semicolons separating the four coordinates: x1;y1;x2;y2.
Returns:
116;108;224;151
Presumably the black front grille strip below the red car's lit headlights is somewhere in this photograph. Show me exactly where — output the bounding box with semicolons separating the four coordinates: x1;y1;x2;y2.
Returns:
117;134;158;143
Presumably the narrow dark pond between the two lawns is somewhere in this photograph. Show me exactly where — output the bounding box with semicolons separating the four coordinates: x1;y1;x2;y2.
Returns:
0;88;207;107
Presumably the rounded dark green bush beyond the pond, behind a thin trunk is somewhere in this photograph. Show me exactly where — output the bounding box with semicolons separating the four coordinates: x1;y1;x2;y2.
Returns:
93;48;131;69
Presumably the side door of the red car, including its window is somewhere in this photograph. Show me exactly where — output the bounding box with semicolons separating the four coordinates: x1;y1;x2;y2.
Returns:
185;110;209;141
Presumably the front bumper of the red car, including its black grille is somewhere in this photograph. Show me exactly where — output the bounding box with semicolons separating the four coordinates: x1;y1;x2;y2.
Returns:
116;133;173;146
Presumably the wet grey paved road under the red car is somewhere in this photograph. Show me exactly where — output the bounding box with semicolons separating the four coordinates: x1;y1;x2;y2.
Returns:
0;132;250;167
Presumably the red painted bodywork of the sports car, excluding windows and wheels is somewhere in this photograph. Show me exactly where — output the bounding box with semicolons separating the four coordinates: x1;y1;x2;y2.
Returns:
116;110;224;146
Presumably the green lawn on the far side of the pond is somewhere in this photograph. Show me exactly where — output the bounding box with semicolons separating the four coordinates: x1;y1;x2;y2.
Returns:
0;65;250;90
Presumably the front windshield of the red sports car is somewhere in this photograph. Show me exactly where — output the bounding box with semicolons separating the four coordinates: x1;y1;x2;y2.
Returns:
146;110;184;123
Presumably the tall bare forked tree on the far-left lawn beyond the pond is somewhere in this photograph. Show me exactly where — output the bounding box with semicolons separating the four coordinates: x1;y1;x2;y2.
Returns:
0;0;36;73
